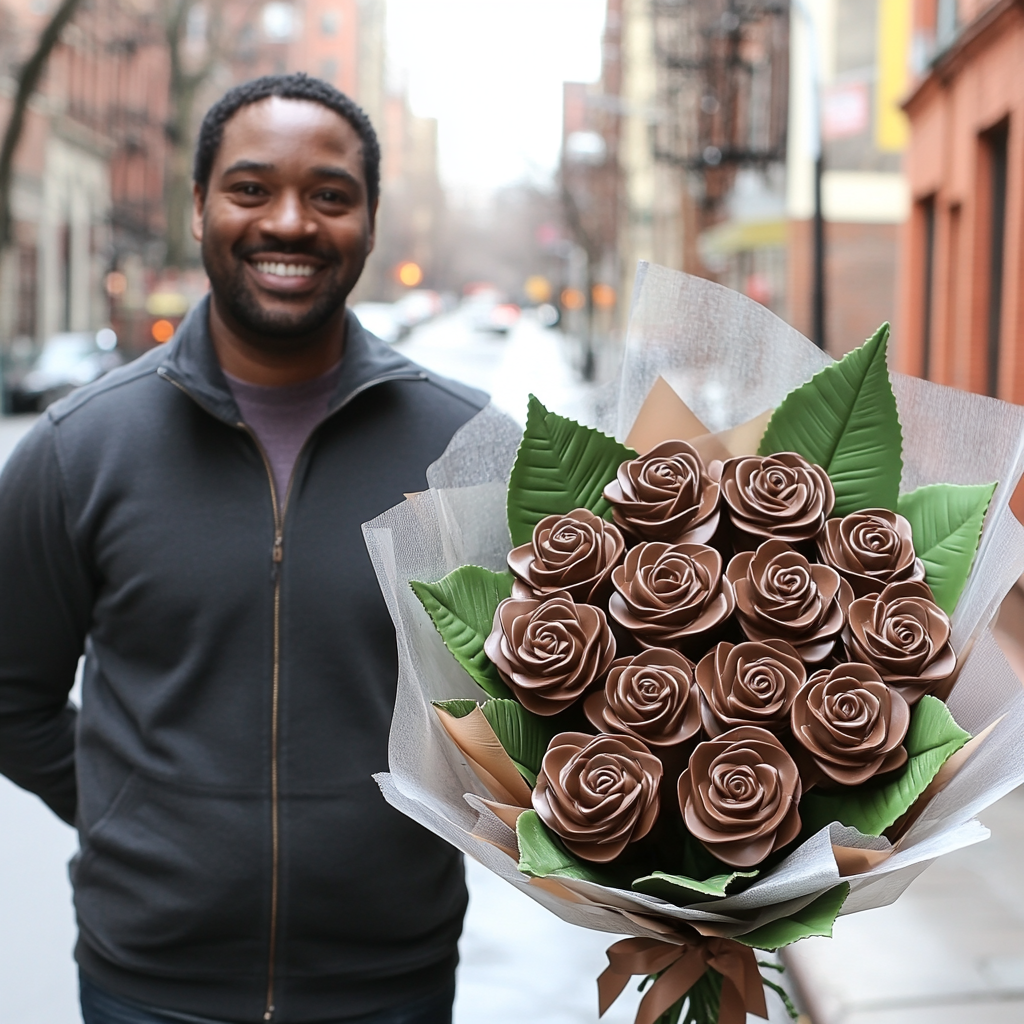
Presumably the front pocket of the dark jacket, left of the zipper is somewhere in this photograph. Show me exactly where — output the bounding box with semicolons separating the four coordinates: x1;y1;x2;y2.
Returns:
73;773;270;978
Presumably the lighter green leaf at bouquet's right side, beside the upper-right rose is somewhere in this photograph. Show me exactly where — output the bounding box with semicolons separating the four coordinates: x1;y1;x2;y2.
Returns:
898;483;995;615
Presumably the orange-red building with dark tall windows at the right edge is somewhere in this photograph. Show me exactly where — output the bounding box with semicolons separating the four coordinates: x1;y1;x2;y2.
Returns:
898;0;1024;402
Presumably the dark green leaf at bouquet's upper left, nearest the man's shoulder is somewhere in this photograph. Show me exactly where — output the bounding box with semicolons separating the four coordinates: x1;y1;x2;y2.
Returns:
508;395;637;545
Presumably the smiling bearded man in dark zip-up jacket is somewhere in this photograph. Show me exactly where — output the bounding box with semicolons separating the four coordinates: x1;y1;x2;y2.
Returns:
0;76;483;1024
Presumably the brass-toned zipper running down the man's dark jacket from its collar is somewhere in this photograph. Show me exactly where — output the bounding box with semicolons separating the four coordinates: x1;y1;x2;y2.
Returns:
157;368;427;1022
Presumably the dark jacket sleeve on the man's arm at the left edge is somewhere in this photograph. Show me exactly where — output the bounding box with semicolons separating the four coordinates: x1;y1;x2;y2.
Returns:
0;415;94;823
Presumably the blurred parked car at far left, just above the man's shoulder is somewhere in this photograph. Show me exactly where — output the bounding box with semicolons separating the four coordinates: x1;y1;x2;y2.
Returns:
8;328;124;413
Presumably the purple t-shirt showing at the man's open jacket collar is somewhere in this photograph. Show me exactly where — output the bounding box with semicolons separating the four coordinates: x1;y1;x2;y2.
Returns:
224;361;341;507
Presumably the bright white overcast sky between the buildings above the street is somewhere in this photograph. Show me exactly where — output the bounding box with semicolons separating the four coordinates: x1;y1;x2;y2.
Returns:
388;0;605;193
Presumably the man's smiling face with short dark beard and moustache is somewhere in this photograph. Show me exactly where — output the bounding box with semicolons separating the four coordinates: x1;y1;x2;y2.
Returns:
193;96;376;351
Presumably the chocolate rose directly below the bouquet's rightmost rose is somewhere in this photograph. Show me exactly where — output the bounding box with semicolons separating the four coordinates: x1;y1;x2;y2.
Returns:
790;663;910;785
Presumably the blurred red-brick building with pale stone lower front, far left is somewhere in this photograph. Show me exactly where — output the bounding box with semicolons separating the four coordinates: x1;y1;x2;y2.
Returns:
0;0;167;346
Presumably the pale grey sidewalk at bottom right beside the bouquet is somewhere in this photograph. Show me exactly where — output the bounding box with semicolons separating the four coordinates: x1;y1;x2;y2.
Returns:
787;588;1024;1024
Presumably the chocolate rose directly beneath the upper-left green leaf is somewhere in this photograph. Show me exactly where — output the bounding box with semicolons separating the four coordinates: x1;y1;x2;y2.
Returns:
508;509;626;604
